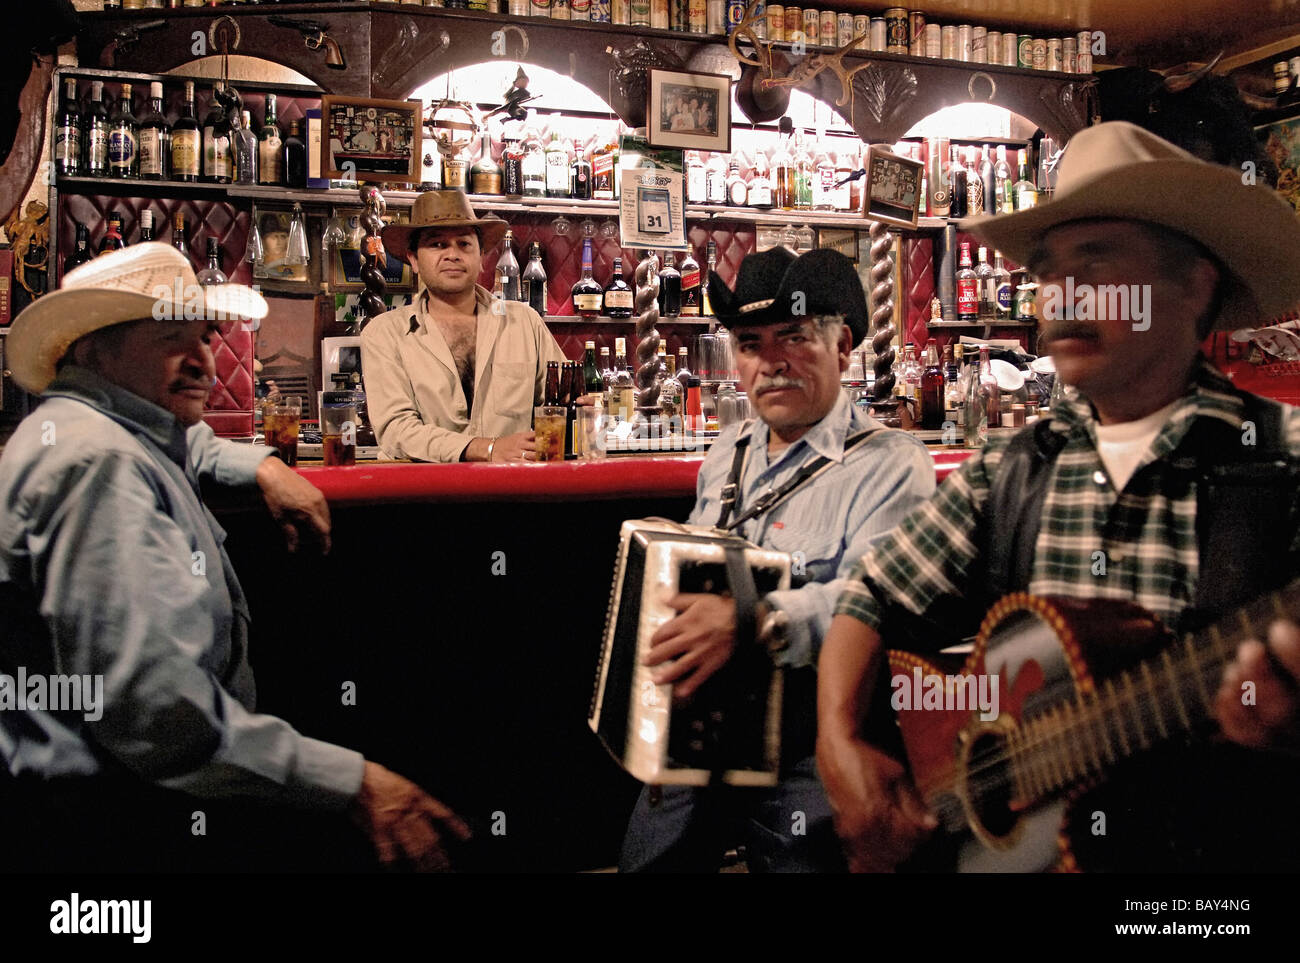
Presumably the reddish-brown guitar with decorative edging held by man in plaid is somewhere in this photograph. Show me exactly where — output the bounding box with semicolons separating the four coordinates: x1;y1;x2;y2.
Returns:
889;581;1300;872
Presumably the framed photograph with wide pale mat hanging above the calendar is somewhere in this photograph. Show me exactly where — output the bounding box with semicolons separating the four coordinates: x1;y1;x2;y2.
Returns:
646;70;732;153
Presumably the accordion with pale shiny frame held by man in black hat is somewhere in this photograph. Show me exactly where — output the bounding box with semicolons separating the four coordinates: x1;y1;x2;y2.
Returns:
588;520;790;786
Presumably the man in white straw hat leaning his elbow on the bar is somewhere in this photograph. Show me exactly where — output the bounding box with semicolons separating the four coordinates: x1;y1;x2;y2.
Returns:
0;243;465;871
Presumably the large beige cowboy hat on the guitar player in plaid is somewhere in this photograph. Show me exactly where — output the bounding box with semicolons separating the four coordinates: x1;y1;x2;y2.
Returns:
961;121;1300;330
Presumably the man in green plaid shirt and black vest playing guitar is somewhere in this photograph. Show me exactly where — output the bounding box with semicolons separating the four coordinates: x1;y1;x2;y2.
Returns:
818;122;1300;871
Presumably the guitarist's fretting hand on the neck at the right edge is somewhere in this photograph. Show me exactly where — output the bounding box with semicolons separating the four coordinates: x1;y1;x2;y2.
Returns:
1214;621;1300;749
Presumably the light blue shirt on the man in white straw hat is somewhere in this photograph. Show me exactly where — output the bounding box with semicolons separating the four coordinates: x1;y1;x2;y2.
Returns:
0;366;364;810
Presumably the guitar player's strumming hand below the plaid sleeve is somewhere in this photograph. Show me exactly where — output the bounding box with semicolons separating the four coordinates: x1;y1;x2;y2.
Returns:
816;737;939;873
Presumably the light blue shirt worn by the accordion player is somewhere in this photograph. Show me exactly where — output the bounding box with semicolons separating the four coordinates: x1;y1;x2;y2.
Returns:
689;392;935;668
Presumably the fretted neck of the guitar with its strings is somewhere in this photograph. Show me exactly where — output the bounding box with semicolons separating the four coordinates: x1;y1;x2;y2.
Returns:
1009;580;1300;802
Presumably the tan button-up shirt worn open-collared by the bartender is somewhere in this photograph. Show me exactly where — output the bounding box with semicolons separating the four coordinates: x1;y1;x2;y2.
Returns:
361;285;564;461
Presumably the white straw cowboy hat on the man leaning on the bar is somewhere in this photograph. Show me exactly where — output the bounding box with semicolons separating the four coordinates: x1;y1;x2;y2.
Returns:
5;240;267;395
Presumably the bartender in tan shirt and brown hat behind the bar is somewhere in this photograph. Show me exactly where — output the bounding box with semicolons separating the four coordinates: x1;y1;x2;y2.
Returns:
361;191;564;461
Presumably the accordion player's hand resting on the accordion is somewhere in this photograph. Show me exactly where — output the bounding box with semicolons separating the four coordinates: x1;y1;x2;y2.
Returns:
645;593;736;702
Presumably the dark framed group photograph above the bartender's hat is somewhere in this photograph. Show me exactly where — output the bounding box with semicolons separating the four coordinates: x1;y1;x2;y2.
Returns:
321;94;424;183
